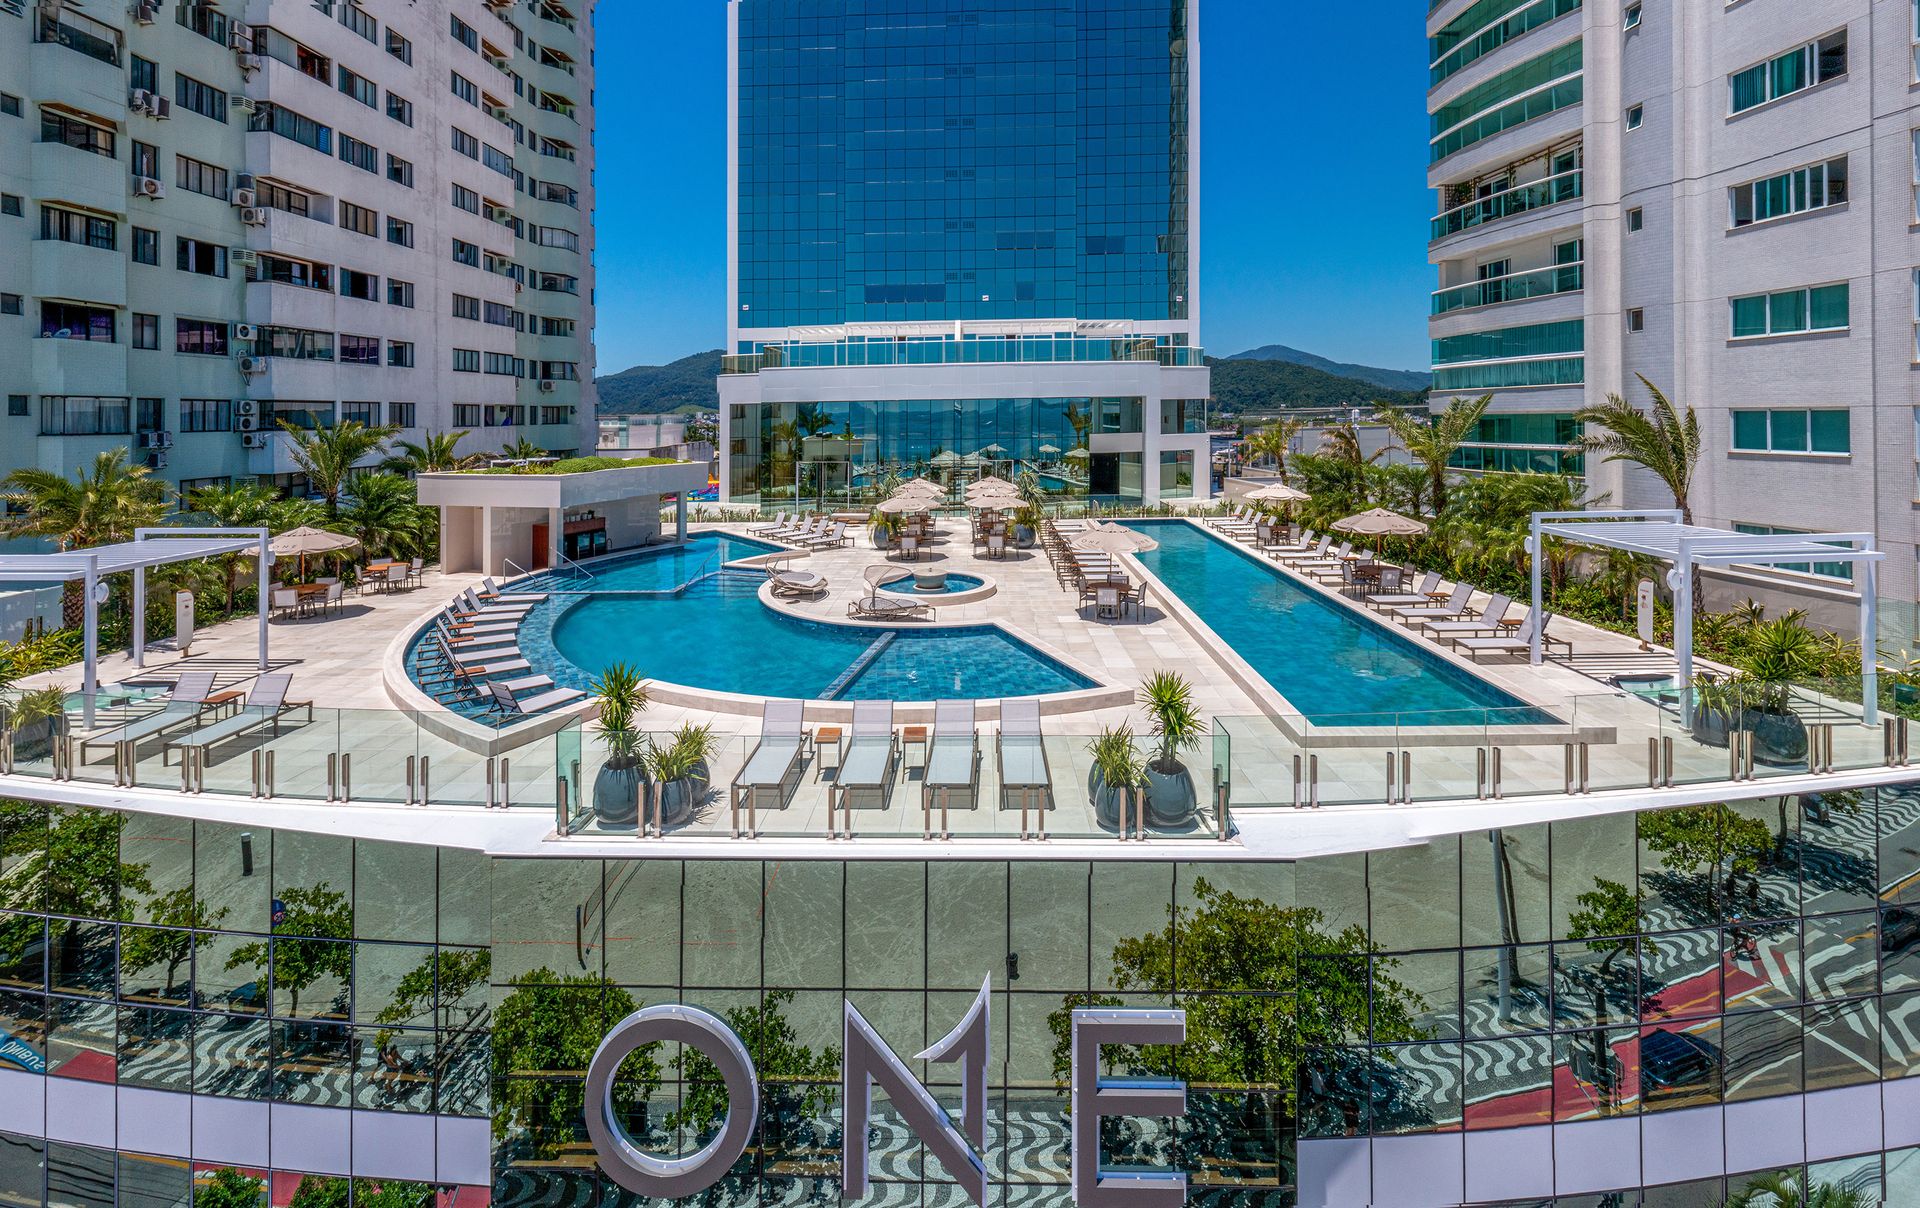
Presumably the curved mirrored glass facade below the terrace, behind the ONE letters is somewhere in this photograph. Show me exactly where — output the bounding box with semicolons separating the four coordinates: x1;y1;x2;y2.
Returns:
0;787;1920;1204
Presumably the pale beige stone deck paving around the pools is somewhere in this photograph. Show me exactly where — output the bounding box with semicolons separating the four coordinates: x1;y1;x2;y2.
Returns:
11;517;1880;839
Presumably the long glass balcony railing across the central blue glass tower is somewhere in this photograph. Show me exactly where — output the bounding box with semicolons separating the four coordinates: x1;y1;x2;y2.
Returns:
720;336;1206;374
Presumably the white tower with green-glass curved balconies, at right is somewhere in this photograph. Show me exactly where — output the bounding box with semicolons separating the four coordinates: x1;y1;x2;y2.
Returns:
1427;0;1920;601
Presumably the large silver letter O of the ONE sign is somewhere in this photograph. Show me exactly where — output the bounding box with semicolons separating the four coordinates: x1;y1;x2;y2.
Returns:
586;1003;760;1200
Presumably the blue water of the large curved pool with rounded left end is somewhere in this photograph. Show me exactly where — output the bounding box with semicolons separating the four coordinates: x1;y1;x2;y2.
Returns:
407;534;1094;701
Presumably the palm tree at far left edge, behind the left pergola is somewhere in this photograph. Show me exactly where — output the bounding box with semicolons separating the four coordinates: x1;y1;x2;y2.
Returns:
0;447;173;628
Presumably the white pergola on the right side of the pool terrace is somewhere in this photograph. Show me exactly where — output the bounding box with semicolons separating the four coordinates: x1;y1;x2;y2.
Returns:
1526;509;1885;726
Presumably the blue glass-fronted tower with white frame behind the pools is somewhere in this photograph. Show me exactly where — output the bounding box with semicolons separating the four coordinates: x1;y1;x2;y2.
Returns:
720;0;1208;503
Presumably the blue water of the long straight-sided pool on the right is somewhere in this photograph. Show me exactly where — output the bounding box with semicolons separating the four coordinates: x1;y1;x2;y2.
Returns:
1127;520;1553;726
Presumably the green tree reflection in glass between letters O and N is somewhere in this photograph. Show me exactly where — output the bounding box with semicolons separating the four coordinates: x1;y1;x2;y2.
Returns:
666;989;841;1206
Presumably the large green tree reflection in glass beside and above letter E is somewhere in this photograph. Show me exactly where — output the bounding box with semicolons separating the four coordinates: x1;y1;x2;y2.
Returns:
1046;878;1427;1154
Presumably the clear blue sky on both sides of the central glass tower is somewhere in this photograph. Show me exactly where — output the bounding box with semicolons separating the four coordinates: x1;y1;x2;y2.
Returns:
599;0;1432;373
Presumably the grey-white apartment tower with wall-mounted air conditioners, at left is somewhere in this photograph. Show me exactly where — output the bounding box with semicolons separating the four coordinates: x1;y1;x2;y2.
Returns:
0;0;595;490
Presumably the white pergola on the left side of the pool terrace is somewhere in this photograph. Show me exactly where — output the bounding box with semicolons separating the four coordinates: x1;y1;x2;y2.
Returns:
0;528;273;714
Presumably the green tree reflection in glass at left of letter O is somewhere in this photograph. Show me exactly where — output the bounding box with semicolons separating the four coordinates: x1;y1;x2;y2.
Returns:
493;970;660;1162
